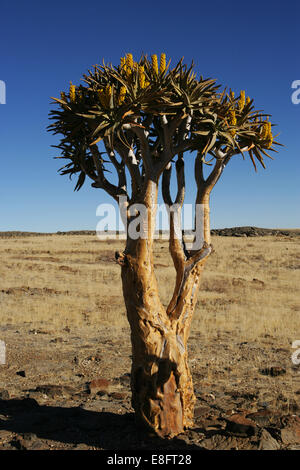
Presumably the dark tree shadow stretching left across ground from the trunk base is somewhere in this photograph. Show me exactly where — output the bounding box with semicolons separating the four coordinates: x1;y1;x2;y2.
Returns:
0;398;201;450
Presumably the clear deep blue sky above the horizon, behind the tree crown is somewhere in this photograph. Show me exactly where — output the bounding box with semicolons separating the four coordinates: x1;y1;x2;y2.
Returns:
0;0;300;232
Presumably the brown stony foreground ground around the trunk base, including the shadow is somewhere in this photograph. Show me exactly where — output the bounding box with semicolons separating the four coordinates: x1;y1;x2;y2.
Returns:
0;323;300;450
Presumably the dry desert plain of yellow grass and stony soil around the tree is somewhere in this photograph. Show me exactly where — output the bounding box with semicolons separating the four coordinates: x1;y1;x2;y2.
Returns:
0;232;300;450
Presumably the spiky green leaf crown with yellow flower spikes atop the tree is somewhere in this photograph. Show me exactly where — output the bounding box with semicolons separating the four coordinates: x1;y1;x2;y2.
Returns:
48;53;280;200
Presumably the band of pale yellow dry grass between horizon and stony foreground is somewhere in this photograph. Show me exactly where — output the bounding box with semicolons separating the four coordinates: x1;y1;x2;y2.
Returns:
0;235;300;344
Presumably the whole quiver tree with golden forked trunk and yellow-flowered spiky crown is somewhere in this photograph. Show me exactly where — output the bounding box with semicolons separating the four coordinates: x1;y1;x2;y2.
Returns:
49;54;276;437
